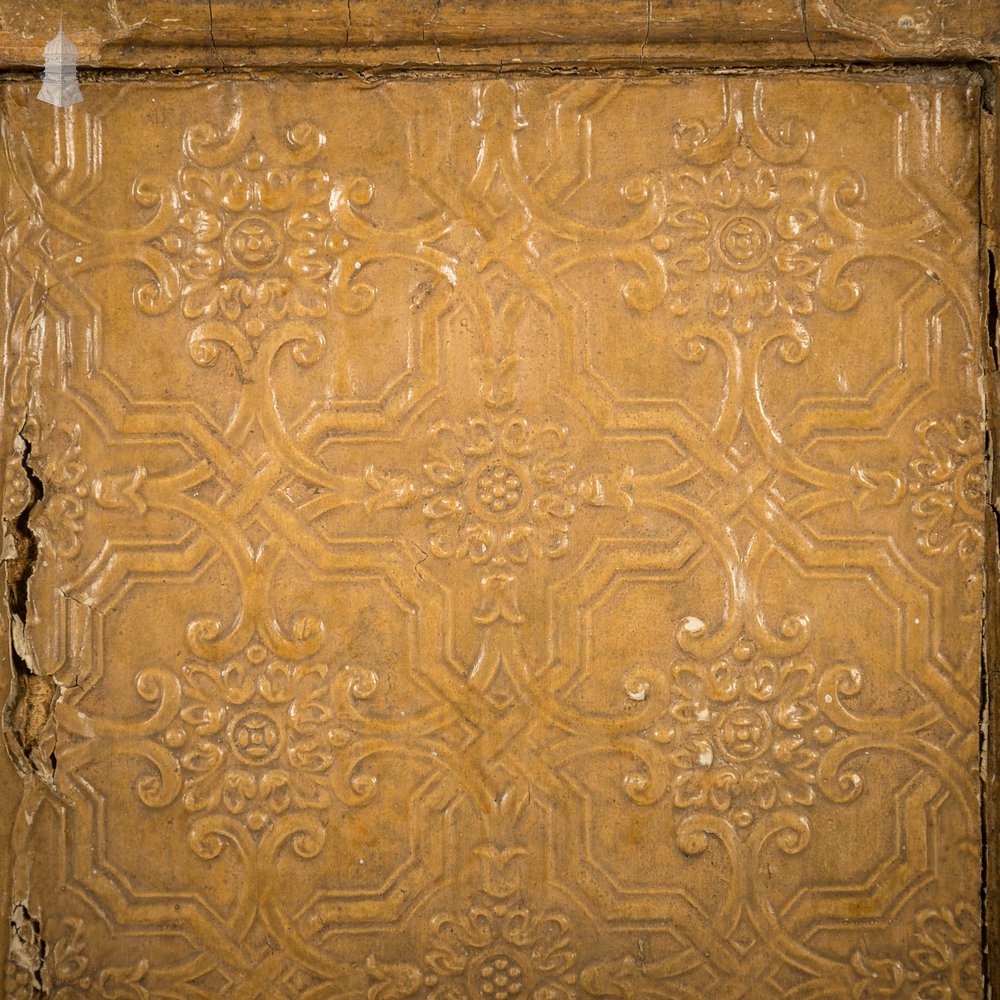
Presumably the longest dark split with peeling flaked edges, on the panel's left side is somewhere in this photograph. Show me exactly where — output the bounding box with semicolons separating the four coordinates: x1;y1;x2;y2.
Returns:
3;416;59;790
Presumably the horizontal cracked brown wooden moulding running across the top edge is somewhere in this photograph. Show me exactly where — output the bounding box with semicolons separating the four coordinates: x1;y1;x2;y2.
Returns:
0;0;1000;69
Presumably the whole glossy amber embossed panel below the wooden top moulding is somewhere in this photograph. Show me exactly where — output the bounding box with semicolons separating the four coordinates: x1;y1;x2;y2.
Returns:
3;71;985;1000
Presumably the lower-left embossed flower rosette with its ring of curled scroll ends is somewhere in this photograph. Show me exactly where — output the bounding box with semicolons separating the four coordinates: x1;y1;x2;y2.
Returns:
110;635;402;858
